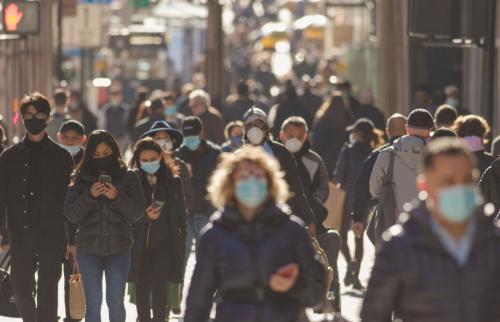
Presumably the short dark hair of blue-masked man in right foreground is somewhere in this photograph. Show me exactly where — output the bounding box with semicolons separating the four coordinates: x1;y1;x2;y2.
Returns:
423;138;477;171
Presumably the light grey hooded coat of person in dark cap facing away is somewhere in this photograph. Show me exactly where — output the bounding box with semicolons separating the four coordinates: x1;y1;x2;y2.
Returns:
370;136;425;226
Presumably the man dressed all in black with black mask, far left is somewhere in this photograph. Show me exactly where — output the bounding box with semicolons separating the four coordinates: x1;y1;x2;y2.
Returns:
0;93;73;322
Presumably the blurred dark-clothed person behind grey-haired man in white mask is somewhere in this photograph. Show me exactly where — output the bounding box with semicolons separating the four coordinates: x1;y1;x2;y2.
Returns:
269;81;313;138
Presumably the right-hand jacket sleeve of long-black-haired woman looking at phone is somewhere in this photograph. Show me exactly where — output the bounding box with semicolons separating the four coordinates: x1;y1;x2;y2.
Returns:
111;172;146;225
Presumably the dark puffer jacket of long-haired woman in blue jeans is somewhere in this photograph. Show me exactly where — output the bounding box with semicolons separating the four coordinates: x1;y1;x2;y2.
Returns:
64;170;146;256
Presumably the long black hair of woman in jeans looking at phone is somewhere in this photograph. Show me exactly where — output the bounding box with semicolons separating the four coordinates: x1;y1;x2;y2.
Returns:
72;130;127;184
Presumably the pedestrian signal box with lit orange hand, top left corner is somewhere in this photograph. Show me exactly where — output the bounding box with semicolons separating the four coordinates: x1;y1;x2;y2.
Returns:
2;0;40;35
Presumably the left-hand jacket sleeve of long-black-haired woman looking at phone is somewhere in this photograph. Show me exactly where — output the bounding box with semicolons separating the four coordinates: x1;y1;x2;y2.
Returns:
64;182;99;224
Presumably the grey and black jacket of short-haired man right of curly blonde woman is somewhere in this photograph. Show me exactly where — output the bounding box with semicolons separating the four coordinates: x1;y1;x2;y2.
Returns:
293;141;330;229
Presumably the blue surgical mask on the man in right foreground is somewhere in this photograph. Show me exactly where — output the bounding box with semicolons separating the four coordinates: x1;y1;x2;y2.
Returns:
438;185;482;223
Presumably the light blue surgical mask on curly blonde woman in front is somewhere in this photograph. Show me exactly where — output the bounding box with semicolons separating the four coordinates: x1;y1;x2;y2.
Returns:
236;176;268;208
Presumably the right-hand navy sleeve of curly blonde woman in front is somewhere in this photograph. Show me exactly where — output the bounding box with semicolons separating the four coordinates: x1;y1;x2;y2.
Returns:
289;221;327;307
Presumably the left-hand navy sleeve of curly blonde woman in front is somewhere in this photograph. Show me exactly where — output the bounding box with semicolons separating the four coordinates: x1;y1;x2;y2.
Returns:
184;229;218;322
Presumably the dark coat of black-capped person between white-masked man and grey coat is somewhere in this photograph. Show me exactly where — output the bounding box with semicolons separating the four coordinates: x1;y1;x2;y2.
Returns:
333;143;372;208
